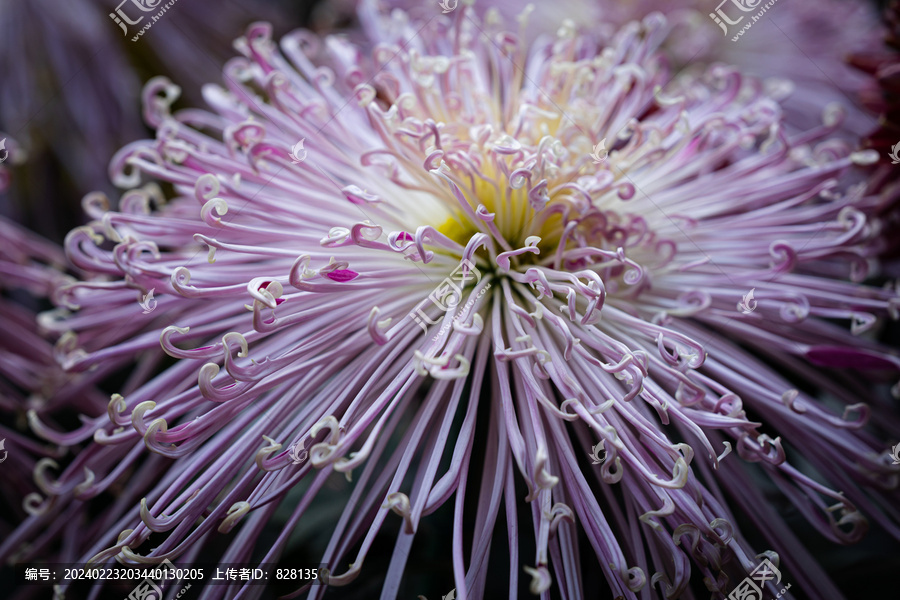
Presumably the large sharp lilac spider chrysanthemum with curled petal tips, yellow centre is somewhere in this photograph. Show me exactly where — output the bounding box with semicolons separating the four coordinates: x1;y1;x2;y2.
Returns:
0;6;900;599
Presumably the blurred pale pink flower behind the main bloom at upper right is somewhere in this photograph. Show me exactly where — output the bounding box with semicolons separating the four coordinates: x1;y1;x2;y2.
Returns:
378;0;884;137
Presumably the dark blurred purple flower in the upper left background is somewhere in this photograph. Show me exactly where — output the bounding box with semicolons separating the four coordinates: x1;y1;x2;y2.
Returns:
0;0;292;238
